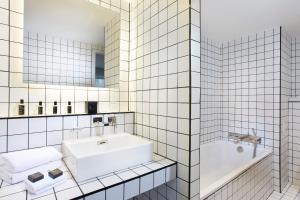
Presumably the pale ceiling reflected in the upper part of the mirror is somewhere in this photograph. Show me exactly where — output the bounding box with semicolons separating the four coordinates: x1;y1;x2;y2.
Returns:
24;0;118;45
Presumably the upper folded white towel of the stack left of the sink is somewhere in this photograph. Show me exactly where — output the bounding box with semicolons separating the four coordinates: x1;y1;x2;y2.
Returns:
0;147;62;173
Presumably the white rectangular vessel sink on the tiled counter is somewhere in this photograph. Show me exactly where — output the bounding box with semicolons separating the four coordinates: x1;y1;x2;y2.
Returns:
62;133;153;181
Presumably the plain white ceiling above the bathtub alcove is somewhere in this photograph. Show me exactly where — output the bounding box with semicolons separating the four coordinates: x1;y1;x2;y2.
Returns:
201;0;300;42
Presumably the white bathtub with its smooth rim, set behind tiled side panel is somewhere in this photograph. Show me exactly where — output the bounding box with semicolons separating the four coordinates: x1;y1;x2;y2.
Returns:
200;141;272;200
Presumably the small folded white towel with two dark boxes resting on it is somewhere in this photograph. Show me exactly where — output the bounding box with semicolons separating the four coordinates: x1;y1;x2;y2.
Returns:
25;173;66;194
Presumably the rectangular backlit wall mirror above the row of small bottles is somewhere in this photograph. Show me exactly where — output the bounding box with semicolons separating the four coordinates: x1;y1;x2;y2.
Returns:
23;0;120;88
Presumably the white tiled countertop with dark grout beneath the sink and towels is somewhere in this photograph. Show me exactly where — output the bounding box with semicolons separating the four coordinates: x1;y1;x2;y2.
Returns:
0;154;176;200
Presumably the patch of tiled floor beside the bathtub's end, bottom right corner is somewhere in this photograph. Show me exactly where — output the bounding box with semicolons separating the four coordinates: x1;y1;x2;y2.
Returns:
268;184;300;200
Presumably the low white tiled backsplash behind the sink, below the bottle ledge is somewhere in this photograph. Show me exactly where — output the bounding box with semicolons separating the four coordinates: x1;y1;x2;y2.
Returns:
0;113;134;153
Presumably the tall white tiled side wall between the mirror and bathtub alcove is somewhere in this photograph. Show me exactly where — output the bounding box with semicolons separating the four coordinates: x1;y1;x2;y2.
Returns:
129;0;192;199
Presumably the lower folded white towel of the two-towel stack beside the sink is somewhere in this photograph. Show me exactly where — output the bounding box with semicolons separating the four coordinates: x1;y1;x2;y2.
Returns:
0;160;62;184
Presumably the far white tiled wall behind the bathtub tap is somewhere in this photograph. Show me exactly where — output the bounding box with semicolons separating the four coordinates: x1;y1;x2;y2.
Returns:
223;28;281;191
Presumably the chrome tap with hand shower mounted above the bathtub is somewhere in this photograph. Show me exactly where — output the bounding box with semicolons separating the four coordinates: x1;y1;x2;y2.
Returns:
228;128;261;158
